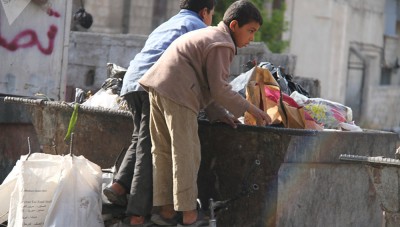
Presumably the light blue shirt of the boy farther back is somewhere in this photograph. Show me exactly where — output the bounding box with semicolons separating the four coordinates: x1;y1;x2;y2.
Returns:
121;9;207;96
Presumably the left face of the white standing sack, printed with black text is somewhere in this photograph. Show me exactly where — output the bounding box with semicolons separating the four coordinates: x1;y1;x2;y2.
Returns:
8;154;62;227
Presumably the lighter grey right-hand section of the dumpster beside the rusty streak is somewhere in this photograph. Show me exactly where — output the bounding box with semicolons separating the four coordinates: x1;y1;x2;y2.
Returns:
276;130;400;227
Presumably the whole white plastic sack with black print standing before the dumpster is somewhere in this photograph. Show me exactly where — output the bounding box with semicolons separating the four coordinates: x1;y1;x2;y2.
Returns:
0;153;104;227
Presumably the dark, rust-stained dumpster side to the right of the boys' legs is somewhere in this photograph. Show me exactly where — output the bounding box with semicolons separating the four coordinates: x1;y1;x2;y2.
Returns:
198;124;397;226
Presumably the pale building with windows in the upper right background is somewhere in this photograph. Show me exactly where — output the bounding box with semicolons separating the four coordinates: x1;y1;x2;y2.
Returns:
284;0;400;130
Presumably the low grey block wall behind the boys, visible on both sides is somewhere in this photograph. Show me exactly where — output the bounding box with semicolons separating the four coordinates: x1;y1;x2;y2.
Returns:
66;32;304;101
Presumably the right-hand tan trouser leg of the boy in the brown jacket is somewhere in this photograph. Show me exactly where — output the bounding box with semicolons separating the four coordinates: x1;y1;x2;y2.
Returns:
148;92;200;211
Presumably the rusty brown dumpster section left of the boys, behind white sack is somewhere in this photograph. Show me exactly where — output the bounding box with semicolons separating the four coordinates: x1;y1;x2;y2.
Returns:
4;97;133;168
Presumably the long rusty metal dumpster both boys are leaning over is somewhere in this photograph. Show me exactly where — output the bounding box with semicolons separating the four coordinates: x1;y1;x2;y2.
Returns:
5;97;397;227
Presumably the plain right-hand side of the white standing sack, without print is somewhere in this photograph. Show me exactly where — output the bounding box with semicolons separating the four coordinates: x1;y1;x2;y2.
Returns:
44;155;104;227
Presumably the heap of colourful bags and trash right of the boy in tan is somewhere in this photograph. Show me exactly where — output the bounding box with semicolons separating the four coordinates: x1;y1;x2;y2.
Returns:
230;62;362;131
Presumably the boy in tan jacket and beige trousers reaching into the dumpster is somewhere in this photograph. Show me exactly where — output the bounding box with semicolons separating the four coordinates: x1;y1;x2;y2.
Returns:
139;0;270;226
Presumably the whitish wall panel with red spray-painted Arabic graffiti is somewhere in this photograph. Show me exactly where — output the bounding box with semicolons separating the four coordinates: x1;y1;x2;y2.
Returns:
0;0;71;100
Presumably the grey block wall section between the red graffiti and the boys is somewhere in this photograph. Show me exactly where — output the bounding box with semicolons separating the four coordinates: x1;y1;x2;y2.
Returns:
66;32;146;100
